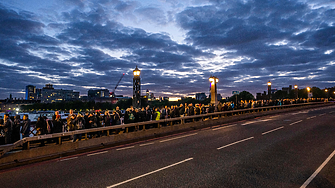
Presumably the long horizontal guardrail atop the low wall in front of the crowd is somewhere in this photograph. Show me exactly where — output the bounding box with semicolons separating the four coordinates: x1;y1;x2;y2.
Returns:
0;102;332;157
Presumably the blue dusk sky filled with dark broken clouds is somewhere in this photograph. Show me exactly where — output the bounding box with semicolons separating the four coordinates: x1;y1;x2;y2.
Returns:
0;0;335;99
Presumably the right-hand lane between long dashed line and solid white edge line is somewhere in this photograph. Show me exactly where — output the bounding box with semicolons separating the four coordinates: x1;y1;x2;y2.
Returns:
121;113;335;187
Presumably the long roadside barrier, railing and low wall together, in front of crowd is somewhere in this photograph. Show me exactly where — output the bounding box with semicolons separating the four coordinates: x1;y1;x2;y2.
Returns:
0;103;334;169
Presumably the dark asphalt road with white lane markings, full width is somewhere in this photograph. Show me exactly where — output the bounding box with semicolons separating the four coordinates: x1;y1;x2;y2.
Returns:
0;106;335;188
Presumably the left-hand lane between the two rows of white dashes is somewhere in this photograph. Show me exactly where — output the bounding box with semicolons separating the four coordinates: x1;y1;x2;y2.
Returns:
1;114;290;187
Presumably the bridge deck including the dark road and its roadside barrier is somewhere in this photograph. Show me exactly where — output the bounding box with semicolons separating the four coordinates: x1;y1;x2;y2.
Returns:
0;103;335;187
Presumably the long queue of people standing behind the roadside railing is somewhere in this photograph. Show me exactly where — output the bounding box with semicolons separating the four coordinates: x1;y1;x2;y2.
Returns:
0;100;316;144
